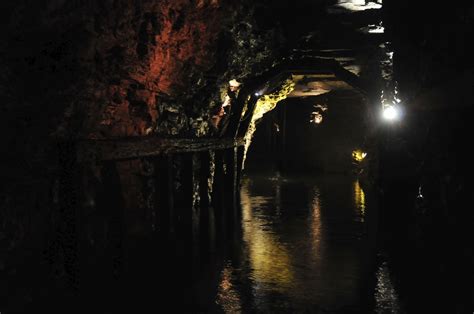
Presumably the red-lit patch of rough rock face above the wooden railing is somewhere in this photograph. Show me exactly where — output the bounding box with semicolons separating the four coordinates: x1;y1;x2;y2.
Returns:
82;0;228;137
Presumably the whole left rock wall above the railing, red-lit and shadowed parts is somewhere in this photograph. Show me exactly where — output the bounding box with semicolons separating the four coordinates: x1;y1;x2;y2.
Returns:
0;0;241;138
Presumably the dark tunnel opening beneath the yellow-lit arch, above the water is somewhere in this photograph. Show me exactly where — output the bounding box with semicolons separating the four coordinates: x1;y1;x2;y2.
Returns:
244;90;367;173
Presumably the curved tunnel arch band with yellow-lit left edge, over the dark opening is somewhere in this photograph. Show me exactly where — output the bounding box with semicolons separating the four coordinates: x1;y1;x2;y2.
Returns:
237;56;368;168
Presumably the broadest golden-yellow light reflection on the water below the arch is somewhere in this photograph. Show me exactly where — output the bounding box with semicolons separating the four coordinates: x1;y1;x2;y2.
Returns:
241;180;294;292
